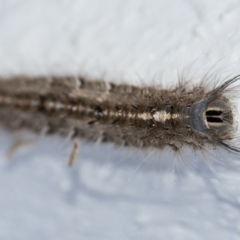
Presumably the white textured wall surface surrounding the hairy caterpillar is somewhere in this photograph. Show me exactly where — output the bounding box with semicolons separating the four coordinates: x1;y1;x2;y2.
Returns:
0;0;240;240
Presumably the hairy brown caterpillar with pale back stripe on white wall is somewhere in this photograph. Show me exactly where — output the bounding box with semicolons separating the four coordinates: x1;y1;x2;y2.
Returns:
0;75;240;163
